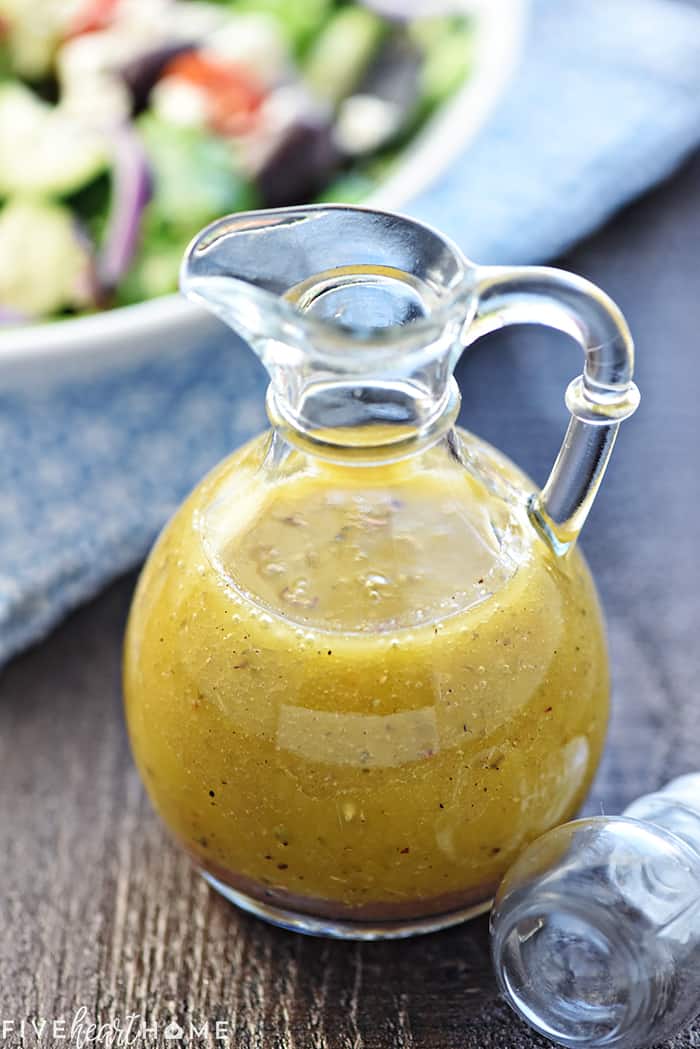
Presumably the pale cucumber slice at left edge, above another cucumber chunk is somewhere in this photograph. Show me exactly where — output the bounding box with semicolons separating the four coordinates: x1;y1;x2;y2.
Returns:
0;82;109;197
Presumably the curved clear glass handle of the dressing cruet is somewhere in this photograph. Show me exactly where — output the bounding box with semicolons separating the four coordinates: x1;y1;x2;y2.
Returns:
465;266;639;554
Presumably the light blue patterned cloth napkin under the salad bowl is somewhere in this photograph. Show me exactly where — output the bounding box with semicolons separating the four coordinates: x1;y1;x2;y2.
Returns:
0;0;700;662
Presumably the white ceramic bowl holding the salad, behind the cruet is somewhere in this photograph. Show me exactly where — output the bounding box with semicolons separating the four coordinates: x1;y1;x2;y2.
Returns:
0;0;527;388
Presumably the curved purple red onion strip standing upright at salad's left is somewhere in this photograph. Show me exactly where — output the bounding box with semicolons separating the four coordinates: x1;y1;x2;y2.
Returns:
98;125;151;291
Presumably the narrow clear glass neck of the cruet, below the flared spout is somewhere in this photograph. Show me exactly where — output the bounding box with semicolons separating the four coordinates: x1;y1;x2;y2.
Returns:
258;272;464;463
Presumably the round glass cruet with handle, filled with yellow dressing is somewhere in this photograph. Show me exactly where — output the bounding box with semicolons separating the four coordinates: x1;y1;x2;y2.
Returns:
124;206;638;939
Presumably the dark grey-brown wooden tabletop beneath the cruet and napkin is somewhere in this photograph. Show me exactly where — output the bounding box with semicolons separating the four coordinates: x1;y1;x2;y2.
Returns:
0;150;700;1049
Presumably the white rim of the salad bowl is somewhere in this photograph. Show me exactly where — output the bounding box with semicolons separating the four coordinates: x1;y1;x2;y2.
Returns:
0;0;529;368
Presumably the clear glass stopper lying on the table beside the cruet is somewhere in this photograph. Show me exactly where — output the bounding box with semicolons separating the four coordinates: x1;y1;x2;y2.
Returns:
491;772;700;1049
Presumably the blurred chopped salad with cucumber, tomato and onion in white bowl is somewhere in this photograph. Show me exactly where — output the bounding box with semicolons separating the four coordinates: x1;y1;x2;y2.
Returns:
0;0;472;325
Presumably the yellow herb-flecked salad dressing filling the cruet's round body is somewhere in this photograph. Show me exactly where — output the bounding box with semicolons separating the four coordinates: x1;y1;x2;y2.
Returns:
125;435;609;920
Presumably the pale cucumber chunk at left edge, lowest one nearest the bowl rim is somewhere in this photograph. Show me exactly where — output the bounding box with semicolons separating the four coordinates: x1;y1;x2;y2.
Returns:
0;199;90;317
